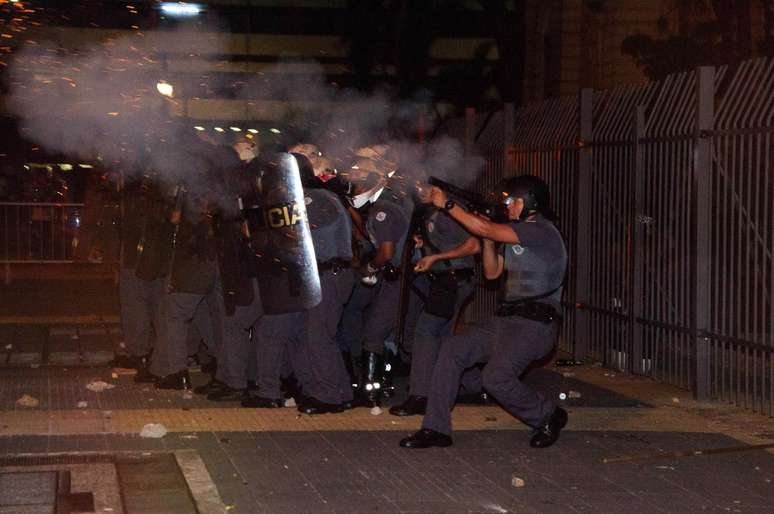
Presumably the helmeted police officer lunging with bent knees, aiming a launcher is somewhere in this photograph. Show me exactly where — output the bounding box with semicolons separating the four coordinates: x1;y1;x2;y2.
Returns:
400;175;567;448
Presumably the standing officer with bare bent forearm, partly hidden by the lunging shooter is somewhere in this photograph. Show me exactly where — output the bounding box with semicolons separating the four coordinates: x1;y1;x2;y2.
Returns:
390;182;481;416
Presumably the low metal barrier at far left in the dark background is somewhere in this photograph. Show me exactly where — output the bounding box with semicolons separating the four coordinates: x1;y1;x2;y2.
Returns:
0;202;84;264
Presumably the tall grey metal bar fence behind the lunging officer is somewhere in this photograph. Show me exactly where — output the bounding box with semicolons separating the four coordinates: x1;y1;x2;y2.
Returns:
448;59;774;415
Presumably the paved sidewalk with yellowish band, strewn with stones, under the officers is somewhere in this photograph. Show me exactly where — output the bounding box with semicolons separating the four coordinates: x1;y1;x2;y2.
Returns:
0;356;774;514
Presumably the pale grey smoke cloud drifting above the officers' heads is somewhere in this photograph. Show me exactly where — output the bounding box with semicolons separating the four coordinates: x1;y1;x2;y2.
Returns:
8;13;483;198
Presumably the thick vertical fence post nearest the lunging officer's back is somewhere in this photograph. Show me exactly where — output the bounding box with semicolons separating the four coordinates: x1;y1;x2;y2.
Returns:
573;89;594;360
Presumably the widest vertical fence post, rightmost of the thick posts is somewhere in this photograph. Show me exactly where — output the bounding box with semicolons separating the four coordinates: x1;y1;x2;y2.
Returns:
691;66;715;400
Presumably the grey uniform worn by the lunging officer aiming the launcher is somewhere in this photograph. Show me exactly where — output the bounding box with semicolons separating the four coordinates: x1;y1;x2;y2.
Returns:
422;214;567;435
